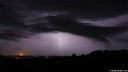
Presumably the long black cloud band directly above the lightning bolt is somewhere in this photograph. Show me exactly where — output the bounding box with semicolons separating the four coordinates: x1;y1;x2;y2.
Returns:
29;16;128;42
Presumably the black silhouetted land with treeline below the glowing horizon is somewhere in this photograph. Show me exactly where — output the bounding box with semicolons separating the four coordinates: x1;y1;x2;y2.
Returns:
0;50;128;72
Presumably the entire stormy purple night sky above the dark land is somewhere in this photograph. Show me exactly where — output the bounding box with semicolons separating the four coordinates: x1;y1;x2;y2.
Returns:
0;0;128;56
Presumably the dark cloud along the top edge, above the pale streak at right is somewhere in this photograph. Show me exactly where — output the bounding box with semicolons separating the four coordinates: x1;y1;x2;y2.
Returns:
19;0;128;18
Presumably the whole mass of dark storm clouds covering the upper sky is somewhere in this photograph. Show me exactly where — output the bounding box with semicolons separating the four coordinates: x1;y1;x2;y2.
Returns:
0;0;128;41
